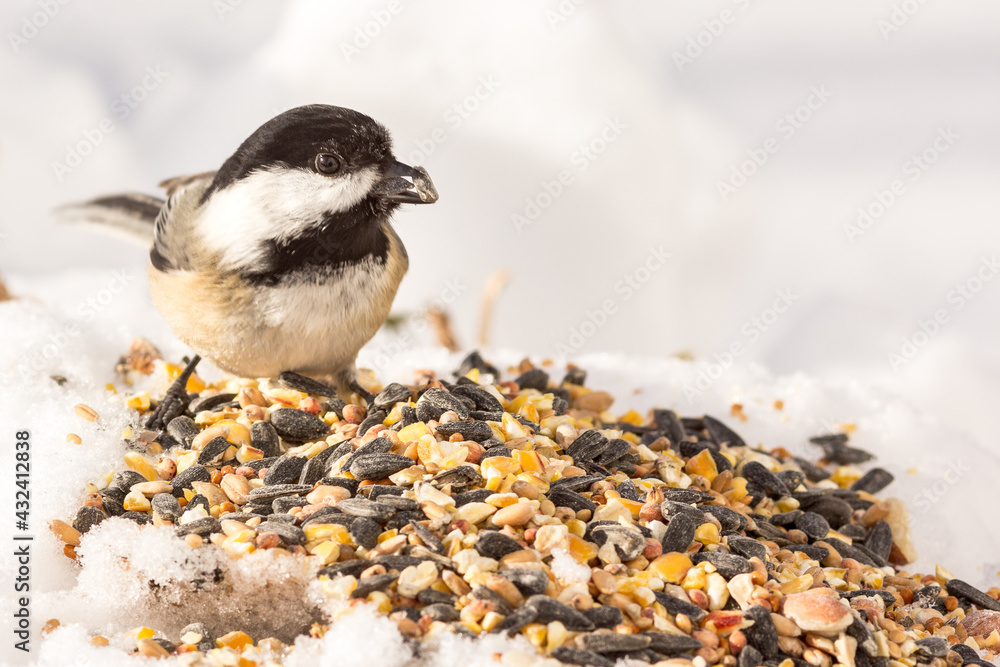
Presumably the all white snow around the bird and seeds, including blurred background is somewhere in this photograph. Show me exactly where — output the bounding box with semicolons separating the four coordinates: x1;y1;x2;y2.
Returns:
0;0;1000;665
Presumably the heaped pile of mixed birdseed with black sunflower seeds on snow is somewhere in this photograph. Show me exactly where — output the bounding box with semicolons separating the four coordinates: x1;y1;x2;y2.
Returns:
50;354;1000;667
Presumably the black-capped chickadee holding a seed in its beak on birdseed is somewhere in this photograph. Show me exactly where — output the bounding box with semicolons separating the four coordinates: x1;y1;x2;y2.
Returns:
59;104;438;408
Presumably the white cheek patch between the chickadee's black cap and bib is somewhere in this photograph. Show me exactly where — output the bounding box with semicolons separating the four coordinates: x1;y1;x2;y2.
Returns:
196;167;378;269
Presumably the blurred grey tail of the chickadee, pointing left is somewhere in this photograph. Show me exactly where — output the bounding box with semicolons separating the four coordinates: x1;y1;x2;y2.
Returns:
56;192;164;248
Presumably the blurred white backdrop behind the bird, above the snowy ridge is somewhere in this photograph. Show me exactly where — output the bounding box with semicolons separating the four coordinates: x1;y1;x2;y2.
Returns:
0;0;1000;446
